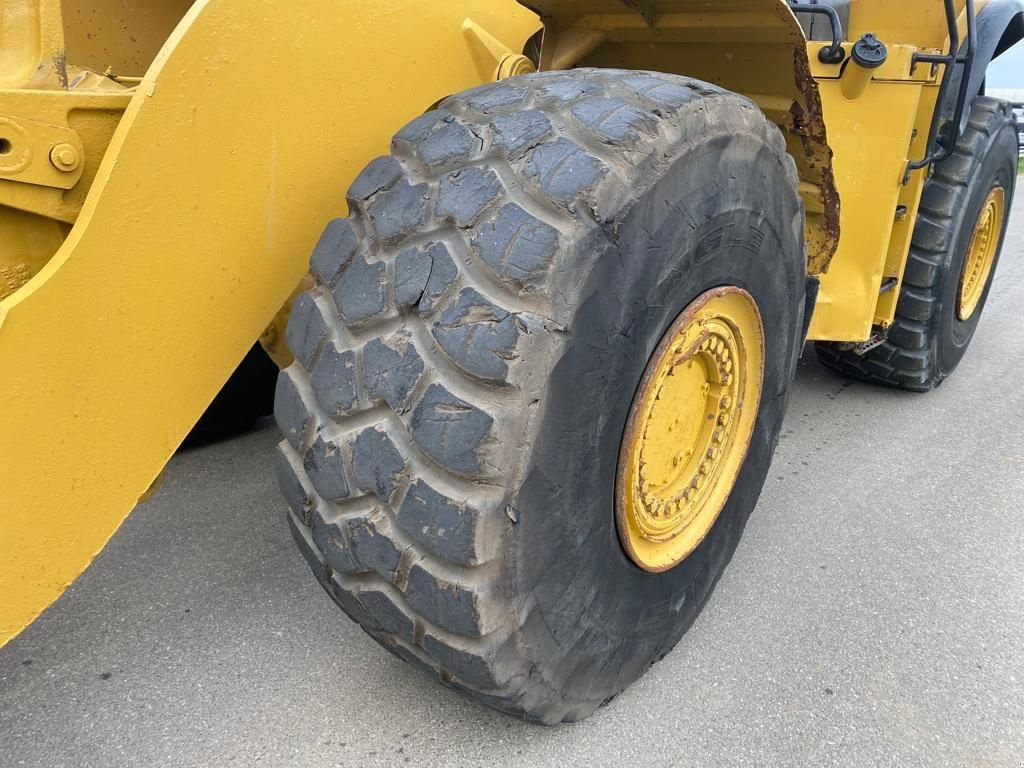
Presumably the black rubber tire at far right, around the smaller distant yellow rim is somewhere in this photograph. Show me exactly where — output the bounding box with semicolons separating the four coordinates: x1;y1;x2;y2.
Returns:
815;96;1018;392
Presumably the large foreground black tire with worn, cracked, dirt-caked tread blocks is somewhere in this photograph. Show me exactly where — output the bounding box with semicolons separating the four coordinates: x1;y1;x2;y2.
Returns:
276;70;806;724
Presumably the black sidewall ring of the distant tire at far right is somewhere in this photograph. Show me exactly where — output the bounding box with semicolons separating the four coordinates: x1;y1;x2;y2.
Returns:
935;124;1018;380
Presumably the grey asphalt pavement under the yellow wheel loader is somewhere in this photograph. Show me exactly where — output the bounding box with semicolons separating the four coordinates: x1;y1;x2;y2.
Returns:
0;193;1024;768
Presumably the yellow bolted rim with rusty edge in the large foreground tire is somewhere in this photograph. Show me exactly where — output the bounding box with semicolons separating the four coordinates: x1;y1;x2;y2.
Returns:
615;287;765;572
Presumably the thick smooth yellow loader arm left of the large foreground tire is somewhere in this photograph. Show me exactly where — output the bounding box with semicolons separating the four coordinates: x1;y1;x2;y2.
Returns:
0;0;539;645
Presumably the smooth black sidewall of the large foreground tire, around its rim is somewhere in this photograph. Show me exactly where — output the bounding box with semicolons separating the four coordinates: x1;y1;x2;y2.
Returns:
511;129;806;701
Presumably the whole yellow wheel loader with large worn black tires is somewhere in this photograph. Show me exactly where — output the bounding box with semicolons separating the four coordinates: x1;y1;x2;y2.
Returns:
0;0;1024;723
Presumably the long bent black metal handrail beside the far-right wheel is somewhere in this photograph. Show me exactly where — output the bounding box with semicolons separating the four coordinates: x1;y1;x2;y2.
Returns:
903;0;978;184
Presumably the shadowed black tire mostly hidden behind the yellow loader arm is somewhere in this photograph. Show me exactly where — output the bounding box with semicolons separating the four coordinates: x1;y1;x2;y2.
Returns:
182;343;278;449
